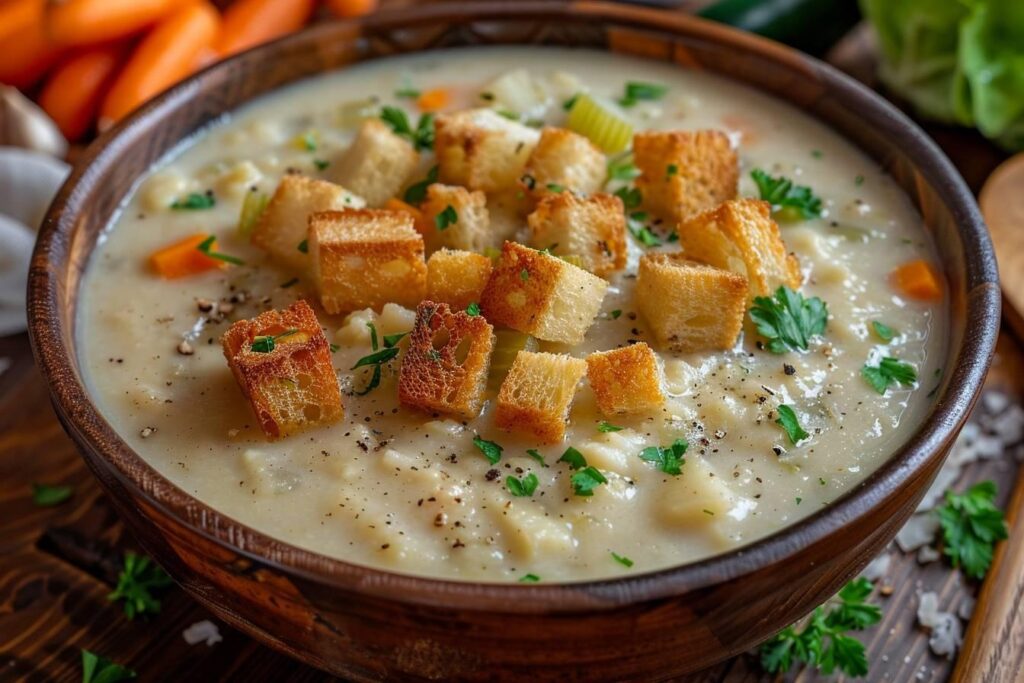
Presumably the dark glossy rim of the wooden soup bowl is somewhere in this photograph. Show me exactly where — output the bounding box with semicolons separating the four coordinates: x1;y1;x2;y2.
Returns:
29;1;999;613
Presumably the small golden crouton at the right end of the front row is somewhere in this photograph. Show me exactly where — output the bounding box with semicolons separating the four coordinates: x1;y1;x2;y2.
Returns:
587;342;665;415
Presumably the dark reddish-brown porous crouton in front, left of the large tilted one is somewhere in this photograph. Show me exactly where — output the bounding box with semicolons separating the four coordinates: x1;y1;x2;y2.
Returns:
398;301;495;420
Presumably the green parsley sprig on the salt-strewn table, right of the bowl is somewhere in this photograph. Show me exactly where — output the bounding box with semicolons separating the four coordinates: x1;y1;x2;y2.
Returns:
936;481;1007;580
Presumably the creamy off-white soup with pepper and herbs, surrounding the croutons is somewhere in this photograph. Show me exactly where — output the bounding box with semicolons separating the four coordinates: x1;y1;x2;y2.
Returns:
78;47;947;582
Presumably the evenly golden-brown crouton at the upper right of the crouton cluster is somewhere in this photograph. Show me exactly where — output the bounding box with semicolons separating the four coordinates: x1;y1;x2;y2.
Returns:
633;130;739;221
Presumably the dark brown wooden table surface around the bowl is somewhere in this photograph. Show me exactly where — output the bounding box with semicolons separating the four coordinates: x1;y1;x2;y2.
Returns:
0;13;1024;683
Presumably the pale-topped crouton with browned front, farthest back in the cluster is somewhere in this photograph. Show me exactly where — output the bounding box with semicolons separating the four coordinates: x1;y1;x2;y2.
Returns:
434;109;541;193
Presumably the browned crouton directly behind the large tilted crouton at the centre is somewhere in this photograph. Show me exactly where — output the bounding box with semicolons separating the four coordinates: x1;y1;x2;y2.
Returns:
526;193;627;278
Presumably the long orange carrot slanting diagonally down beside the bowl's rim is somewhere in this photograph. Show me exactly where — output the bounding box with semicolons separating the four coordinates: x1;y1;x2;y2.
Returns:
99;1;220;130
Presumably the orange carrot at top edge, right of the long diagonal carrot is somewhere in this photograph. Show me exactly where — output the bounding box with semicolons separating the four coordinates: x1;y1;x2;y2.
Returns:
215;0;316;57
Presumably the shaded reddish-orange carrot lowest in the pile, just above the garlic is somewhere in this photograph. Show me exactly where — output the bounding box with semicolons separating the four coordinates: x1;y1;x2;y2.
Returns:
39;45;125;142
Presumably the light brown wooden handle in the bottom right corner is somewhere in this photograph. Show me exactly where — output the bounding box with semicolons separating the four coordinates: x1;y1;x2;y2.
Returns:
950;467;1024;683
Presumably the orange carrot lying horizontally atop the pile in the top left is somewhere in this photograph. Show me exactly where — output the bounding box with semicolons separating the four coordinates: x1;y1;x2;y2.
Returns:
46;0;182;45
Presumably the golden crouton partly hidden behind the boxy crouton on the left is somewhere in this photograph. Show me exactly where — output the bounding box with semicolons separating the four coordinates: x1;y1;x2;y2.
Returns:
252;174;366;268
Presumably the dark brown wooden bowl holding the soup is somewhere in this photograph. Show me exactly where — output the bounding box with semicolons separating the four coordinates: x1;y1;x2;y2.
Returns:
29;2;999;680
